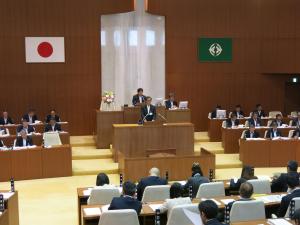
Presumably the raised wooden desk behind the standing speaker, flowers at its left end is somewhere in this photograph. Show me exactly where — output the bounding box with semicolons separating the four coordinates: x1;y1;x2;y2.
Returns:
96;107;191;148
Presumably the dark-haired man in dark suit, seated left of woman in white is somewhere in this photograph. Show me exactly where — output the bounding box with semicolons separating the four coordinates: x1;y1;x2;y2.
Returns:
108;181;142;215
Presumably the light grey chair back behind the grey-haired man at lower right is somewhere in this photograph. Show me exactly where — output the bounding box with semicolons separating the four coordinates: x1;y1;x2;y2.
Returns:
230;200;266;223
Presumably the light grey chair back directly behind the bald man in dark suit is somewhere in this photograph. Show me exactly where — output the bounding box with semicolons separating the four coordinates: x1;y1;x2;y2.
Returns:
142;185;170;203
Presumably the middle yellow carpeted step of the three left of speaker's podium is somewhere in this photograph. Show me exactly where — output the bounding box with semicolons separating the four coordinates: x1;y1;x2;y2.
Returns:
72;146;113;160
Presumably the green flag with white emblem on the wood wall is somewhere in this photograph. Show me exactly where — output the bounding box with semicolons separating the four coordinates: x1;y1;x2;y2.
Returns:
198;38;232;62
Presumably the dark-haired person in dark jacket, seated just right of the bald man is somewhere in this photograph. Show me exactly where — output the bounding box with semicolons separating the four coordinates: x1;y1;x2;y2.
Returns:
184;163;209;198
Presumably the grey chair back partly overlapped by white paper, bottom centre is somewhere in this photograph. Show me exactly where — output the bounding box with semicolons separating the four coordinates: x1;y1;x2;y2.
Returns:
167;204;200;225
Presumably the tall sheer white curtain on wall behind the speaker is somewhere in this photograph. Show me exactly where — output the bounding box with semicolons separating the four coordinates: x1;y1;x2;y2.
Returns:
101;0;165;106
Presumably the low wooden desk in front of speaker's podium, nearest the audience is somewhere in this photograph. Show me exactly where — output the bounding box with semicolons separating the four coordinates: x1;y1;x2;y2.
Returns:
118;149;216;182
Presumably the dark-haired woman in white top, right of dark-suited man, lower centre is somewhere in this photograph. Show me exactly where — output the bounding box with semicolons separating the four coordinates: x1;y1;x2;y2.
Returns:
159;182;192;216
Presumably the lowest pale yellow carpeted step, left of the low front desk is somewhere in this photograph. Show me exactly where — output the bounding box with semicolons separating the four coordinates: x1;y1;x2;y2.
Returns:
72;159;119;176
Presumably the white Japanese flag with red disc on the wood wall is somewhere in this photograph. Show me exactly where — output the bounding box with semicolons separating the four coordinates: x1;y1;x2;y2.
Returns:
25;37;65;63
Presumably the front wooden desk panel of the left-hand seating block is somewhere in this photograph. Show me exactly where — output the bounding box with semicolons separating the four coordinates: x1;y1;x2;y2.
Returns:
0;145;72;181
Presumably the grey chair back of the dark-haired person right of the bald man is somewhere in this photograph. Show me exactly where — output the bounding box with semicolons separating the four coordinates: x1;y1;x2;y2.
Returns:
196;182;225;198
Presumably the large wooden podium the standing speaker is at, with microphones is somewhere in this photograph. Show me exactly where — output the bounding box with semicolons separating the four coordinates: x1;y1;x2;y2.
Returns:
113;123;194;162
